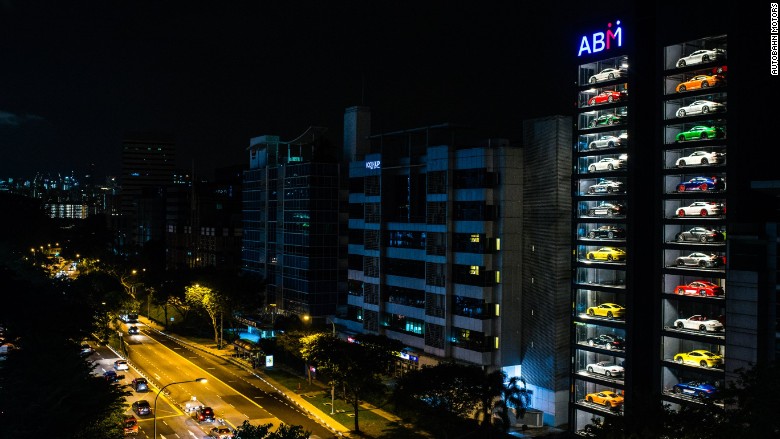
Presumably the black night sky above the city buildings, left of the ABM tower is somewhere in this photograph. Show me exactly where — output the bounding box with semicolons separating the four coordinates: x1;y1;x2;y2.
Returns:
0;0;603;179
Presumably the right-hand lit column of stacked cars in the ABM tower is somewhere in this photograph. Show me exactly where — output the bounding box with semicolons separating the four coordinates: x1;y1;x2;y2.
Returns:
659;35;729;408
